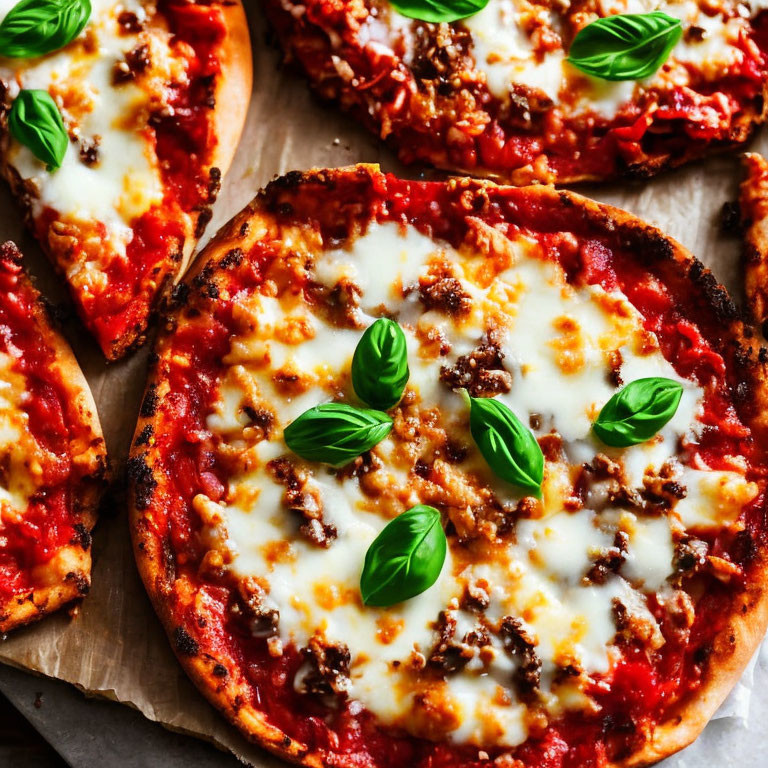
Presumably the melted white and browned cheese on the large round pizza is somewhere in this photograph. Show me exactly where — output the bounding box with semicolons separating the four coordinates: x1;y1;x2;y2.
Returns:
200;223;755;746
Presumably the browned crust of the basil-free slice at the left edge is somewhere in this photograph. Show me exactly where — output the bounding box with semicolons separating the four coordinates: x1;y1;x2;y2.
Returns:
0;249;108;633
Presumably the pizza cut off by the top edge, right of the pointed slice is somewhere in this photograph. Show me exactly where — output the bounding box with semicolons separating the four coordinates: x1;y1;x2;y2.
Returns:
265;0;768;184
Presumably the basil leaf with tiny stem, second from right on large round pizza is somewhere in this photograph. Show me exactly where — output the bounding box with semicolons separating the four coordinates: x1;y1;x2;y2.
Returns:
464;393;544;498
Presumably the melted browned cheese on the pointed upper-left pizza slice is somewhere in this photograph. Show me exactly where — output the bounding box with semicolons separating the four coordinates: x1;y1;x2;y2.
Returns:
0;0;186;264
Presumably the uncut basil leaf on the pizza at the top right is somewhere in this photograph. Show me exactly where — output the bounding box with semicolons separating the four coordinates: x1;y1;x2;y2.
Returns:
568;11;683;80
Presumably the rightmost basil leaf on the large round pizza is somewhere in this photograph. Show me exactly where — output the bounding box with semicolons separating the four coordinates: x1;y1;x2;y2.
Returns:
592;376;683;448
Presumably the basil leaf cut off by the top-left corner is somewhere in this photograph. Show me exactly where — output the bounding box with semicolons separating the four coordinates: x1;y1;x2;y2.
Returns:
0;0;91;59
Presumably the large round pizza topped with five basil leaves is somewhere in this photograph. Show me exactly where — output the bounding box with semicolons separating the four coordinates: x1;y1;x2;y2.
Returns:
129;165;768;768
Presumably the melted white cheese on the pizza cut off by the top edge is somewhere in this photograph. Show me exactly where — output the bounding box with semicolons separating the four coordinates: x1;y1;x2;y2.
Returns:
368;0;760;119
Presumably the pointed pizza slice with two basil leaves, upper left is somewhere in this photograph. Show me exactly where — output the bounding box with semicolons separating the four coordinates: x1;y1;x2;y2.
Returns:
0;0;251;359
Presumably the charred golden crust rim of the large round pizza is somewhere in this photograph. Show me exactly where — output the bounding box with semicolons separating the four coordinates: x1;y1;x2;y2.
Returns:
130;164;768;768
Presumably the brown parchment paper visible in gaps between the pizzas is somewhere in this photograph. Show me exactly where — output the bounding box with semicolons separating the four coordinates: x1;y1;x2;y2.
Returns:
0;3;768;768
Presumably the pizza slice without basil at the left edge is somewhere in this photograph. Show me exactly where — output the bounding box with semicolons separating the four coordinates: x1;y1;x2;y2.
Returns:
0;242;107;633
